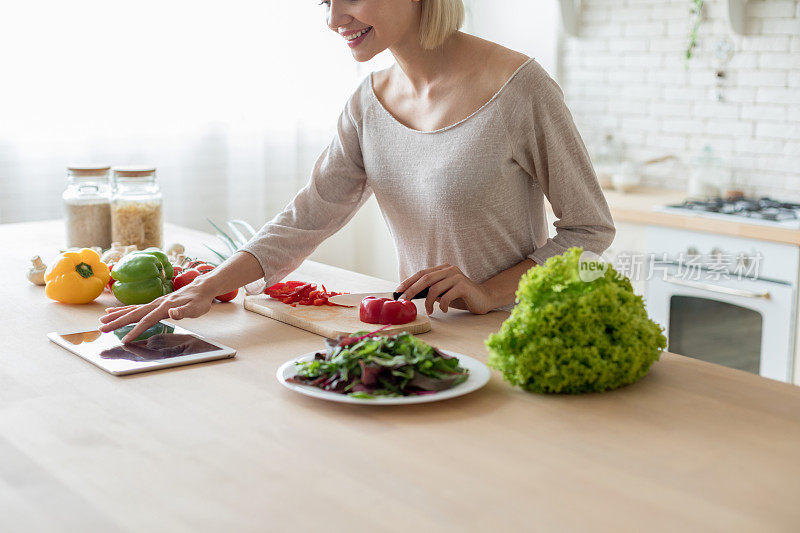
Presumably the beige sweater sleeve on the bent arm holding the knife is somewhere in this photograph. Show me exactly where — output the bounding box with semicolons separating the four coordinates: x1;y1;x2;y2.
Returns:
504;64;615;264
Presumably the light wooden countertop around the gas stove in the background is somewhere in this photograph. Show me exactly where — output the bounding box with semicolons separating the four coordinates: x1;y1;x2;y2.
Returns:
604;188;800;246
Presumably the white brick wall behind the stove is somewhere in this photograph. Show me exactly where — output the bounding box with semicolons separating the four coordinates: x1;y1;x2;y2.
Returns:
559;0;800;200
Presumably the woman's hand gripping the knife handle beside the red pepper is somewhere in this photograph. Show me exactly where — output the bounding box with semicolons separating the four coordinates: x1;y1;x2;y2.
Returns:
395;263;494;315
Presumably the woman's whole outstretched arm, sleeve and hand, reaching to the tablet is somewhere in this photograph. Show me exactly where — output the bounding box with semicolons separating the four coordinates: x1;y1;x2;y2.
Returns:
100;93;372;342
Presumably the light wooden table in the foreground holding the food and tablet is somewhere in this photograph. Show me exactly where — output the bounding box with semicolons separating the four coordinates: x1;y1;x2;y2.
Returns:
0;222;800;532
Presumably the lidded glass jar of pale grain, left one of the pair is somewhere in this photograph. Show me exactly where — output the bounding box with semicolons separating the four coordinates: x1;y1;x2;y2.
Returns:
61;165;111;248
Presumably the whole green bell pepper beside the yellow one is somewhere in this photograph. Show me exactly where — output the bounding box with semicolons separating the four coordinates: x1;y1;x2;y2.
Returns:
111;248;174;305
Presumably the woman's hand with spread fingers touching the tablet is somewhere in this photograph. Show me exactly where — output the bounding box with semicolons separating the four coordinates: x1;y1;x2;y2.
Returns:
99;276;219;343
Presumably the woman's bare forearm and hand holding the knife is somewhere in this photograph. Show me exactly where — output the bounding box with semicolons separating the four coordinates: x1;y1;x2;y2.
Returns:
395;259;536;315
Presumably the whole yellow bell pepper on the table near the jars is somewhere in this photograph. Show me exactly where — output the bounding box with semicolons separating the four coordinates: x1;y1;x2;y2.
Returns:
44;248;109;304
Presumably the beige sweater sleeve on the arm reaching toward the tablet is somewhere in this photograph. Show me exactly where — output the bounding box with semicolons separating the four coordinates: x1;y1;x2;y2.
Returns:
240;102;372;291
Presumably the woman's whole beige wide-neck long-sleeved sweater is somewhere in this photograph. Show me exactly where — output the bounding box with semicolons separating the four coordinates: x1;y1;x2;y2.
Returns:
242;59;614;304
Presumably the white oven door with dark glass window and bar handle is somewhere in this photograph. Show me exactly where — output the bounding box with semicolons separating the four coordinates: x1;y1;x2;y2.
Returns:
647;265;795;383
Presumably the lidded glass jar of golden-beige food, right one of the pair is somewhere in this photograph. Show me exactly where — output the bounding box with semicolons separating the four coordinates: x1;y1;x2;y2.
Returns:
111;167;164;250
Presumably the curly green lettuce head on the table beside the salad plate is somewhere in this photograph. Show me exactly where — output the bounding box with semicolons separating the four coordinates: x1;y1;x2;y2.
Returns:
486;248;667;394
